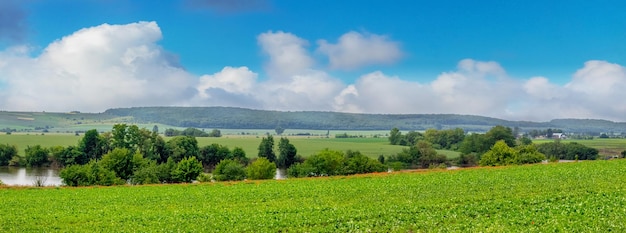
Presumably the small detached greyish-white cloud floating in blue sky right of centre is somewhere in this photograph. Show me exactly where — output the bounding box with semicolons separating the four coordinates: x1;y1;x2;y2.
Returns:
317;31;402;70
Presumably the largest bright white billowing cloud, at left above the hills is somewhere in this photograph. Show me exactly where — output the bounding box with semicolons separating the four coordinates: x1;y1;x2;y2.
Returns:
0;22;195;111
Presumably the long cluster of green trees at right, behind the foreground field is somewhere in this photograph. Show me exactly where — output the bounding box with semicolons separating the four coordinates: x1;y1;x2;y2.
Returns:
380;125;599;168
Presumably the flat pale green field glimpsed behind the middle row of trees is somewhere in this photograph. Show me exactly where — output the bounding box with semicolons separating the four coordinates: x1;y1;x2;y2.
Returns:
0;132;458;158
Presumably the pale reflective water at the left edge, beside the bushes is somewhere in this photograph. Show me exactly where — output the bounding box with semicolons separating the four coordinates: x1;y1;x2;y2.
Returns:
0;167;62;186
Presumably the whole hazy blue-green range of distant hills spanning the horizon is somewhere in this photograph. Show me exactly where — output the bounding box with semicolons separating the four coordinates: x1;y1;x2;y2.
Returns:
0;107;626;134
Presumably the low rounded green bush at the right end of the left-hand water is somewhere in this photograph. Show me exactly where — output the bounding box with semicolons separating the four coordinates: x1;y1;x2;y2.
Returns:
59;161;124;186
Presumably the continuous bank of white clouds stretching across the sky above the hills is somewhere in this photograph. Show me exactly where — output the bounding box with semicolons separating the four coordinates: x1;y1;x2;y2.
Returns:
0;22;626;121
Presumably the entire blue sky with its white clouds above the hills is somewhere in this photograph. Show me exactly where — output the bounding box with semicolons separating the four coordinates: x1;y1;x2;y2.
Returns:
0;0;626;121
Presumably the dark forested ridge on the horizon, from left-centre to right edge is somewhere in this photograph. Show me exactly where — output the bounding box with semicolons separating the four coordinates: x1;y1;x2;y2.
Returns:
103;107;626;133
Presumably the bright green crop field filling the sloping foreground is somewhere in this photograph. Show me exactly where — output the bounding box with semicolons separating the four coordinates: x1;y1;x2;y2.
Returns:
0;160;626;232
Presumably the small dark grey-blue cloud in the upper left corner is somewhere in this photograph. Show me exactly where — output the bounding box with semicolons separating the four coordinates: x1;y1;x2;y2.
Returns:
0;0;26;42
